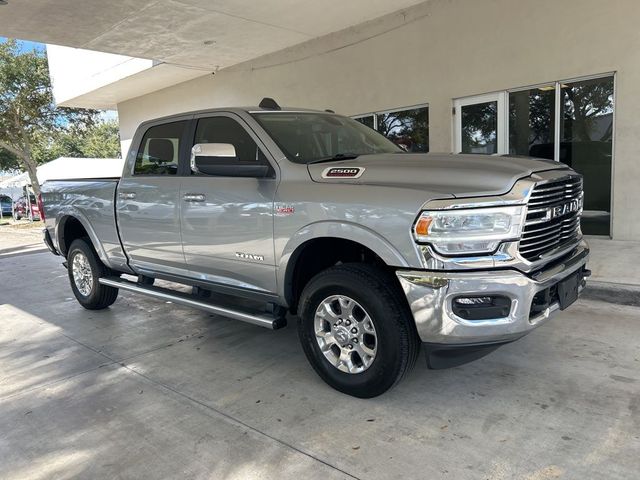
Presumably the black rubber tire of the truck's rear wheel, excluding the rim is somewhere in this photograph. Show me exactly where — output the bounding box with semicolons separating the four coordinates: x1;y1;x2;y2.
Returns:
67;238;118;310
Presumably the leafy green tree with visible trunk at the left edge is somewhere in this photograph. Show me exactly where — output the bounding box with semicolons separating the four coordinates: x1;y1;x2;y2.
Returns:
0;40;99;195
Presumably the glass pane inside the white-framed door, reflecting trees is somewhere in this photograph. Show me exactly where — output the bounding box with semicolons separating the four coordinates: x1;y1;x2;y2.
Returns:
461;102;498;155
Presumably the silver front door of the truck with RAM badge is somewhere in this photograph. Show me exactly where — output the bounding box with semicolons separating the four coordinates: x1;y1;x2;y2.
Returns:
180;113;277;293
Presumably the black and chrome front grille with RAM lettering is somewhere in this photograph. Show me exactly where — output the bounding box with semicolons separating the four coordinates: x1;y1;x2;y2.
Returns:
519;175;582;262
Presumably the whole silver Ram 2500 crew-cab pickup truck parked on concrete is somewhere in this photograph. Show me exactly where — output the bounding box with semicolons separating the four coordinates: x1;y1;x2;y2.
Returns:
42;99;589;397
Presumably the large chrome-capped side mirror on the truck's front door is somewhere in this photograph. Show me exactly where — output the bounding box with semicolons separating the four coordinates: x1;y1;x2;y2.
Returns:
191;143;269;178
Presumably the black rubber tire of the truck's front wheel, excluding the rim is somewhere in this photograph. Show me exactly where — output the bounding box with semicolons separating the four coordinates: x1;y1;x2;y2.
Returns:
298;263;421;398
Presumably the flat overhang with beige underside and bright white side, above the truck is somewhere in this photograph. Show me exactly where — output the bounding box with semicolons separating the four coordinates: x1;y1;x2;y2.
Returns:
0;0;424;108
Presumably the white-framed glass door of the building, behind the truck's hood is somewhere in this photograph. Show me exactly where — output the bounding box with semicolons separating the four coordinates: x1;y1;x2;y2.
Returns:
454;92;508;155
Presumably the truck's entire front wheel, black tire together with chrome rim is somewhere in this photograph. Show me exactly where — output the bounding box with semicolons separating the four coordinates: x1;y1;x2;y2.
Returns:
298;263;420;398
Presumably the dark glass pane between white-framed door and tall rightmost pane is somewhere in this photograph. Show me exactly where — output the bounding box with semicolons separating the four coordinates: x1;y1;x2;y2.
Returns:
509;85;555;160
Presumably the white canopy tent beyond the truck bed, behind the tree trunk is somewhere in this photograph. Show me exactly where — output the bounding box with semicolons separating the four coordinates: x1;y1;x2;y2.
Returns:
0;157;124;200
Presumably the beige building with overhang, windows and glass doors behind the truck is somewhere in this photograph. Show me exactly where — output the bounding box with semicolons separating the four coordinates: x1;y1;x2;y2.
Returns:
0;0;640;240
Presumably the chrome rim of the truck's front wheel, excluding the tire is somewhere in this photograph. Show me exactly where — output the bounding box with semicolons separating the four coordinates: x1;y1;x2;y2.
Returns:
314;295;378;373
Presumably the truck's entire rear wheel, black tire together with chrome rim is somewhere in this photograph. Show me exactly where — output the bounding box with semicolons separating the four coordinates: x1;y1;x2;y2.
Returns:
67;238;118;310
